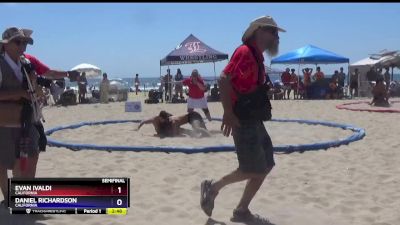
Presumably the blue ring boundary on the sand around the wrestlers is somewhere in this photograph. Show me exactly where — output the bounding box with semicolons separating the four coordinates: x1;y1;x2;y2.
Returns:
45;118;365;154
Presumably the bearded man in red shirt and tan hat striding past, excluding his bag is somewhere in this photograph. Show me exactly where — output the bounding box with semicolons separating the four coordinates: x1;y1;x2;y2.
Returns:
200;16;285;222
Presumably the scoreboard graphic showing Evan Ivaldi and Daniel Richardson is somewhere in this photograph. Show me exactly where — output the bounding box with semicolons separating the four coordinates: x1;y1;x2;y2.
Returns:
8;178;130;215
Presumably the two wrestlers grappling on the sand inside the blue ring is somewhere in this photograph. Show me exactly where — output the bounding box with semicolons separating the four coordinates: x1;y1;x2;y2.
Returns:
136;111;211;137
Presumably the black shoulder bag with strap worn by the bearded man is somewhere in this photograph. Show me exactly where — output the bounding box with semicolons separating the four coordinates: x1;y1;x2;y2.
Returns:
233;45;272;121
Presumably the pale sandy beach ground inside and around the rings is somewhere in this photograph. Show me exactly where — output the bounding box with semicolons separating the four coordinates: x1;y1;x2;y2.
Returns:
0;94;400;225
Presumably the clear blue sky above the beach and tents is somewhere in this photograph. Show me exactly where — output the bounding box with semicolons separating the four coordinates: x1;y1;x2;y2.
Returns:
0;3;400;78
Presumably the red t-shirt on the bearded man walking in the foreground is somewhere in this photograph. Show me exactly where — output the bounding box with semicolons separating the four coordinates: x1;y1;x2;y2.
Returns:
223;43;265;103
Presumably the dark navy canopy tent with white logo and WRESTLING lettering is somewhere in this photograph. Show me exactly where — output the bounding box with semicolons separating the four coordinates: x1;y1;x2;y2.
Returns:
160;34;228;102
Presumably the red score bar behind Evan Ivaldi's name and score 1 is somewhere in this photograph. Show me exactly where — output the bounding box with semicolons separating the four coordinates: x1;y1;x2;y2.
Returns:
31;184;128;196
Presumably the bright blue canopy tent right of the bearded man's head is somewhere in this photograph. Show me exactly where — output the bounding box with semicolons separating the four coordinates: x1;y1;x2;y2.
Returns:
271;45;349;98
